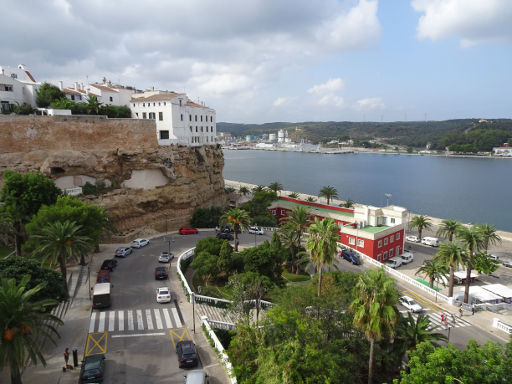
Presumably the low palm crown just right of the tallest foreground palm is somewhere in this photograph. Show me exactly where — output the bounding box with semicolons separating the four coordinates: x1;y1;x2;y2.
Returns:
400;312;448;351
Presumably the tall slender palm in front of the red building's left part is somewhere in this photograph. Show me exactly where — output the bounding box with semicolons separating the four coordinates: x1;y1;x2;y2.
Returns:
306;217;340;296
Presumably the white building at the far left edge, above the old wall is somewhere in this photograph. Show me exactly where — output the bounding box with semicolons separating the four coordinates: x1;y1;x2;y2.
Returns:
0;64;41;112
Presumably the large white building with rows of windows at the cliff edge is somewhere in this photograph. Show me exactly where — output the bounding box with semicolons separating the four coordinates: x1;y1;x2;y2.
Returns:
130;91;217;146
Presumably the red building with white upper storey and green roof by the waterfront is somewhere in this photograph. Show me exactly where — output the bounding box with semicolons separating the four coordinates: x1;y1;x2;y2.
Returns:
269;197;407;262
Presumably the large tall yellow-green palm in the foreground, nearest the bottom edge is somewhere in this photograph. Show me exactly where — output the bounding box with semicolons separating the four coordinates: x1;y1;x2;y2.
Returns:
349;269;398;384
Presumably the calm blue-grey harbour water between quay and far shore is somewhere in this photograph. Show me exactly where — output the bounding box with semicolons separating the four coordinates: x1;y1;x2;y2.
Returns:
223;149;512;232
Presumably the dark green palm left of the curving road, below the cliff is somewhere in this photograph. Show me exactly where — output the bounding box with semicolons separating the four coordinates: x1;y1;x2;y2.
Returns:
32;220;94;284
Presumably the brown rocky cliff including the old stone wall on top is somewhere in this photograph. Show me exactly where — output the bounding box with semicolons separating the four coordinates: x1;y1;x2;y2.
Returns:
0;116;226;240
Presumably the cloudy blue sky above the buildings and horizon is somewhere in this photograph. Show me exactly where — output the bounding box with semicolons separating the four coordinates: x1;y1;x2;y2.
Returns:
0;0;512;123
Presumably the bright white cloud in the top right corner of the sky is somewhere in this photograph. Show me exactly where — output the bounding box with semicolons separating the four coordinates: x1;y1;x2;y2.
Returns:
411;0;512;46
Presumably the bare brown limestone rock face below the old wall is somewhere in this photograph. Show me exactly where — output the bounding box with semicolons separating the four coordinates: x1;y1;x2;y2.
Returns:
0;115;226;238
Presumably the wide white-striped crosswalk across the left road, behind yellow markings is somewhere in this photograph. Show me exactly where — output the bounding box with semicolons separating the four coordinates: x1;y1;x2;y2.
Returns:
89;307;183;333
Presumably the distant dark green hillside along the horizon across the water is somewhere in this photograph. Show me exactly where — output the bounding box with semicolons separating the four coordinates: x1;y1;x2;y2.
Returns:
217;119;512;152
